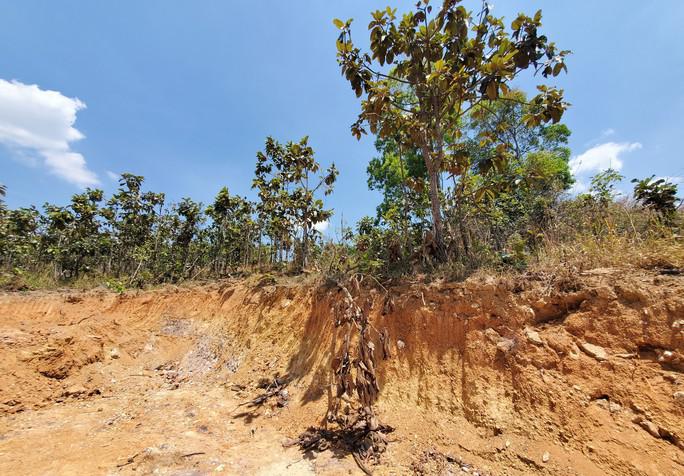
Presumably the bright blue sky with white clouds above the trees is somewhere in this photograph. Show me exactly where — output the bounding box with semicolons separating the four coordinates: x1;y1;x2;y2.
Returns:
0;0;684;231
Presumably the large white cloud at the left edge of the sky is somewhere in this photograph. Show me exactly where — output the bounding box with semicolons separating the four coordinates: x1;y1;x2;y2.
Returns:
0;79;100;187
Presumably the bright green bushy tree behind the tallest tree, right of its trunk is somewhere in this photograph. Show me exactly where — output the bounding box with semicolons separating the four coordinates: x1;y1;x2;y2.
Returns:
468;90;574;248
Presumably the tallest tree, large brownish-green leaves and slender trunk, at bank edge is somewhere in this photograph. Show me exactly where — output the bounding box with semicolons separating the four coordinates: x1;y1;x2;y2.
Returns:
334;0;568;260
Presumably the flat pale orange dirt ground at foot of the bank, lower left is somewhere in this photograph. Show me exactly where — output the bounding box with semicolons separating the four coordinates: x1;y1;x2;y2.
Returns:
0;377;342;475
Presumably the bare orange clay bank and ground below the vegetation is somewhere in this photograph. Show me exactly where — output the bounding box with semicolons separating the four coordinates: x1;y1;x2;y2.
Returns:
0;269;684;475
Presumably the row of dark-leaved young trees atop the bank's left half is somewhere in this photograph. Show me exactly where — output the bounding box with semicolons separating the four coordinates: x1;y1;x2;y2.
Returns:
0;137;337;289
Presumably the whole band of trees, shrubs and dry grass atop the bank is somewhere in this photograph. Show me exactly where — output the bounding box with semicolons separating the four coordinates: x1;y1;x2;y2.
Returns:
0;0;684;292
